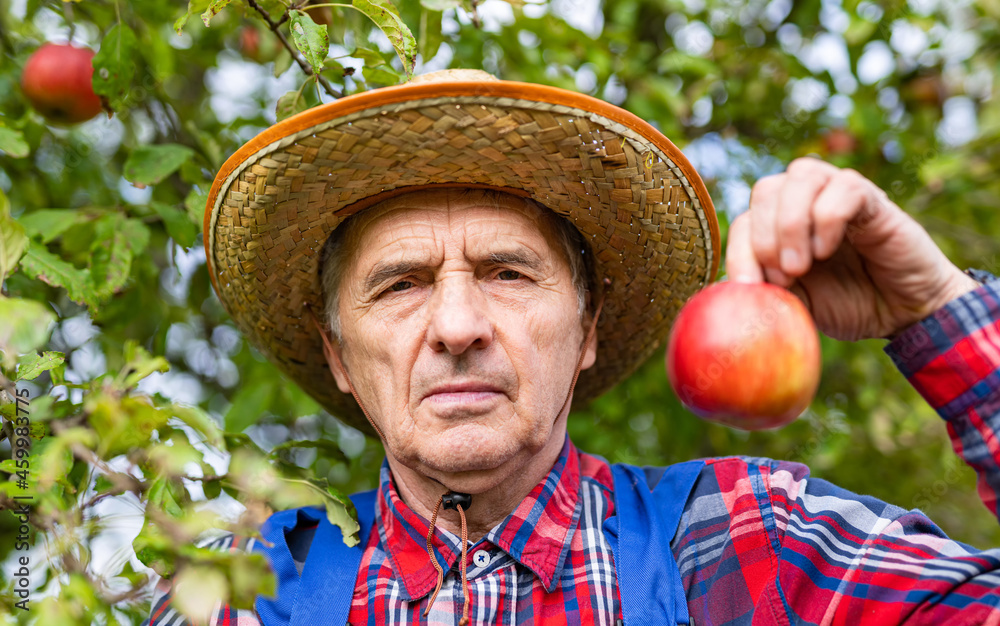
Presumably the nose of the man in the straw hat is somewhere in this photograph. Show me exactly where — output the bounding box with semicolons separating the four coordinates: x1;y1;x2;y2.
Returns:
427;277;493;355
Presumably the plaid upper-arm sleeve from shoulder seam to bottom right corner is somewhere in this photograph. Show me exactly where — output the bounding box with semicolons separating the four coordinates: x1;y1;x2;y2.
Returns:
757;461;1000;625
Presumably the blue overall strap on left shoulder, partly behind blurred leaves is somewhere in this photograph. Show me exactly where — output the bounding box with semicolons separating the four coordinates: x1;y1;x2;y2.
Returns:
254;489;375;626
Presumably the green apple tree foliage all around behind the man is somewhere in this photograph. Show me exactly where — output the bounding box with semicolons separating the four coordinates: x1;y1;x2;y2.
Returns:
0;0;1000;625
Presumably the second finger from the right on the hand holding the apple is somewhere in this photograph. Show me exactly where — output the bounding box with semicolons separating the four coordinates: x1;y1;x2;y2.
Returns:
775;158;840;276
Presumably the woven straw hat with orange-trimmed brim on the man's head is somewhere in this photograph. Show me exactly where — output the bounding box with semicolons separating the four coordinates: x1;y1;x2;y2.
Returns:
205;70;719;433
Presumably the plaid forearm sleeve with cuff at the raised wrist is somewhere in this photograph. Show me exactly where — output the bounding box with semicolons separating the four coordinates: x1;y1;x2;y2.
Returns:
885;279;1000;515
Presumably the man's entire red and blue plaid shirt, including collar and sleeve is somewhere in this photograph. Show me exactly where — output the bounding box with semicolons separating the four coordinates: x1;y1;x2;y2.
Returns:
143;282;1000;626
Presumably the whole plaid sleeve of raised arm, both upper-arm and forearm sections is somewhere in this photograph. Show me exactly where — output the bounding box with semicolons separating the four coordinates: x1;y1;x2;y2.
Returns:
752;281;1000;624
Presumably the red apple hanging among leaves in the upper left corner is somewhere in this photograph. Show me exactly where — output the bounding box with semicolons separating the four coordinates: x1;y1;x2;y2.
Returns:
21;43;101;124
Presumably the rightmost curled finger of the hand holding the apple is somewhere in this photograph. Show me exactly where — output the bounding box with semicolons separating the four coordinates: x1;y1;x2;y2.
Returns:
812;170;874;259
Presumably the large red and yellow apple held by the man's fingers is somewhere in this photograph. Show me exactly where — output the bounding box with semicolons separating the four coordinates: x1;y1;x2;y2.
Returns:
667;282;820;430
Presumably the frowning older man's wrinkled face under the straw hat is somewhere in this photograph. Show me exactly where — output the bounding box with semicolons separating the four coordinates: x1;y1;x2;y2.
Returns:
328;190;596;489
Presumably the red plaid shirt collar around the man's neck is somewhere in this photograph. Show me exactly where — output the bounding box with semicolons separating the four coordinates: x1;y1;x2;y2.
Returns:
375;437;581;601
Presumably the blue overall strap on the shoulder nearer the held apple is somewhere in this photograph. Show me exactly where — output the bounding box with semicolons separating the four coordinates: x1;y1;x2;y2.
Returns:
604;461;704;625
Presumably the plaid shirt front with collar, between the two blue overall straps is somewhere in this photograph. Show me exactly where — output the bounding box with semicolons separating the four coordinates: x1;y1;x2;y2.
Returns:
349;440;621;626
